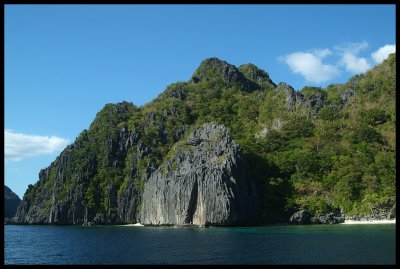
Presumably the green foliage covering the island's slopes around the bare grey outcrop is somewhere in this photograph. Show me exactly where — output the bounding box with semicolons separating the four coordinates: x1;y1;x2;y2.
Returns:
21;54;396;222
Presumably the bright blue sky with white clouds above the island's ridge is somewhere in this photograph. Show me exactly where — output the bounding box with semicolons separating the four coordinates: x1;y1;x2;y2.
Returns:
4;5;395;198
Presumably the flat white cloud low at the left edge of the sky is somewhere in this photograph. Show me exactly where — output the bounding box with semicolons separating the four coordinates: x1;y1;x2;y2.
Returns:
4;129;69;161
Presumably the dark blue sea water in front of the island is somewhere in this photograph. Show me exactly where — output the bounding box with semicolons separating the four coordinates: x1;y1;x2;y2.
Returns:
4;224;396;264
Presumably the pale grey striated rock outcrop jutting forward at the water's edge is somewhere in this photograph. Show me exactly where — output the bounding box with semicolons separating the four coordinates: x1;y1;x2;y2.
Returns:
141;123;260;226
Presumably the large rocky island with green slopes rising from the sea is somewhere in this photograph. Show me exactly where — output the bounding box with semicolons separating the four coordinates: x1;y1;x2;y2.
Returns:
10;54;396;226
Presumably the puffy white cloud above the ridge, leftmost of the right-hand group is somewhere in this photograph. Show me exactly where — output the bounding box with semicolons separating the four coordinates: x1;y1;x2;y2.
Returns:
283;49;339;83
